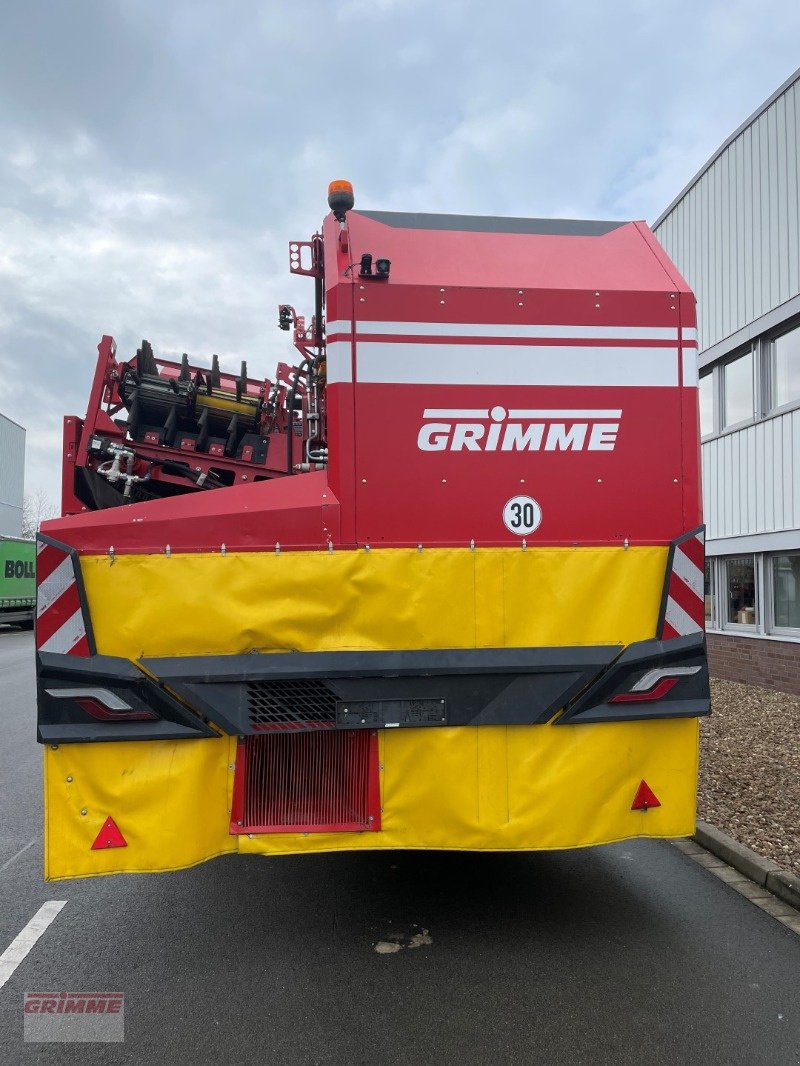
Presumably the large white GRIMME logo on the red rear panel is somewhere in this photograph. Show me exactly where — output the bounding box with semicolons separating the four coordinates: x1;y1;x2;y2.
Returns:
417;406;622;452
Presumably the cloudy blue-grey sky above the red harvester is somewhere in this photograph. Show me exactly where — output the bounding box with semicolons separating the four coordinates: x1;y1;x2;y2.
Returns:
0;0;800;500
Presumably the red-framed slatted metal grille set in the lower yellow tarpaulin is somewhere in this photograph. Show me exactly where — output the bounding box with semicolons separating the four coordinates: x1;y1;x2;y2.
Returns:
230;729;381;833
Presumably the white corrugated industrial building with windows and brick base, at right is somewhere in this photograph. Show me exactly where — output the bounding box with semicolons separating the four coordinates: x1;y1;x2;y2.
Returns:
653;70;800;694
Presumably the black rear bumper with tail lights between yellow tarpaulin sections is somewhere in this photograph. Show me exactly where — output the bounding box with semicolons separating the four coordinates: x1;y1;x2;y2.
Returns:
38;633;710;743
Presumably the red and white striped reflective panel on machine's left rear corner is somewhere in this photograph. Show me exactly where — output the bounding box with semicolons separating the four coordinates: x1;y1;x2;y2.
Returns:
36;540;91;656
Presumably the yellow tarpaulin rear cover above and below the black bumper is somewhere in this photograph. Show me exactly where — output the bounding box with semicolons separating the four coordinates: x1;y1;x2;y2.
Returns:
45;548;698;878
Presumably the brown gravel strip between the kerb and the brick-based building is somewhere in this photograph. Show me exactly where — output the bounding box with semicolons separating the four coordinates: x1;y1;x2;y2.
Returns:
698;680;800;874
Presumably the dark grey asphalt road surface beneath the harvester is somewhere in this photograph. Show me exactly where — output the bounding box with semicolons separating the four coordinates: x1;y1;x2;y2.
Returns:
0;628;800;1066
